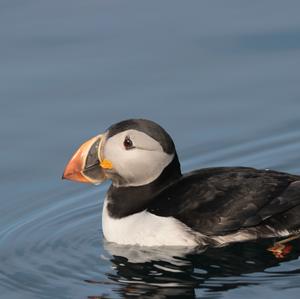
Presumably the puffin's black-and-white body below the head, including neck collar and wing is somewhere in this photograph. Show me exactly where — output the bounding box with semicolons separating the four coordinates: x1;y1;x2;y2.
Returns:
102;167;300;246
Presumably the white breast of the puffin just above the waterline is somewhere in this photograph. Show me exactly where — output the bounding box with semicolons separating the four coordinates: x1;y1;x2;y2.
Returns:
102;199;197;246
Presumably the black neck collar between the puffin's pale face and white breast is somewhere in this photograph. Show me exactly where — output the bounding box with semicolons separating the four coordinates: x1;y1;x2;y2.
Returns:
107;153;182;218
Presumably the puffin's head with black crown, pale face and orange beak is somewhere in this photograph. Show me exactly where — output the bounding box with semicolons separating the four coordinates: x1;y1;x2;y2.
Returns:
63;119;180;187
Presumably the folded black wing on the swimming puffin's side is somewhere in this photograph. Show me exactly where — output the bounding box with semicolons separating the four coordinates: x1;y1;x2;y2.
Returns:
148;167;300;235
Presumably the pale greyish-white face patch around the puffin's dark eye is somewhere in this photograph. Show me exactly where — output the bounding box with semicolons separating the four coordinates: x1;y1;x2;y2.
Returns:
102;130;174;186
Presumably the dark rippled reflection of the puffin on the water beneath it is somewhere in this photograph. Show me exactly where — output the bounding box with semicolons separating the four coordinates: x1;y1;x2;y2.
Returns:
90;239;300;298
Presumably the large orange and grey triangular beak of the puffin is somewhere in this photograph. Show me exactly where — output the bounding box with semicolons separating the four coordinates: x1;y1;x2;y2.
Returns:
62;135;106;184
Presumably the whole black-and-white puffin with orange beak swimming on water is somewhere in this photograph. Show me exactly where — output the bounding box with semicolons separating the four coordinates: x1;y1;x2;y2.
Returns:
63;119;300;247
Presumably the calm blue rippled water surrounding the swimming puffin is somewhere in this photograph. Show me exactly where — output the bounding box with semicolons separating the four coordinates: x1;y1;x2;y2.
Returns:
0;0;300;299
